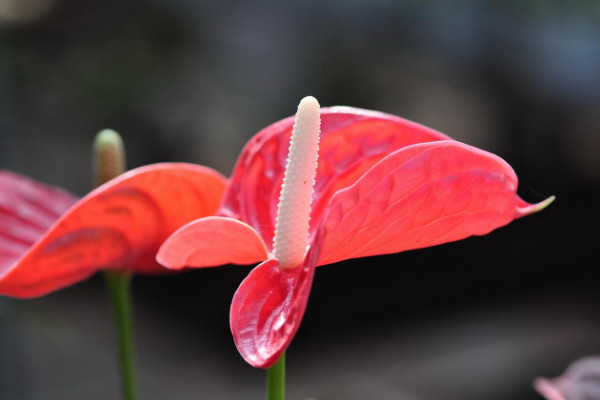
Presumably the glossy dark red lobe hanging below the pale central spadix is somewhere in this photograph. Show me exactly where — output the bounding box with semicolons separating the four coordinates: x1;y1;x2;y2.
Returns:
230;228;319;368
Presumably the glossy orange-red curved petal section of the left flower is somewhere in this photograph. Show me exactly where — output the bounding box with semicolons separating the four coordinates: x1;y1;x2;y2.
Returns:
0;164;226;297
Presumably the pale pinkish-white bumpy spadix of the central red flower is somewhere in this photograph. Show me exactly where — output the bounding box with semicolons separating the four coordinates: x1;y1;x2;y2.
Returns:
273;96;321;268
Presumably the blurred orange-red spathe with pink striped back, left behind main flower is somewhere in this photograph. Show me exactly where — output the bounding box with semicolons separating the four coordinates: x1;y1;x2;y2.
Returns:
0;163;227;298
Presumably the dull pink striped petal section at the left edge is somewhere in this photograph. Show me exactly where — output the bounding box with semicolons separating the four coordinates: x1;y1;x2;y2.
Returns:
0;171;77;276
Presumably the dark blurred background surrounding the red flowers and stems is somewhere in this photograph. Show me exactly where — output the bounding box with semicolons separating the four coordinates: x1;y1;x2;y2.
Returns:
0;0;600;400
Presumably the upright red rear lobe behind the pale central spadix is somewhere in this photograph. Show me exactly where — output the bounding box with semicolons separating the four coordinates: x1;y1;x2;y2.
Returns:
219;107;449;252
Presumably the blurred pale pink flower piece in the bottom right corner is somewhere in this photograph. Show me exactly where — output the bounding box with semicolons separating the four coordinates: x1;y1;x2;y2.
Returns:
533;356;600;400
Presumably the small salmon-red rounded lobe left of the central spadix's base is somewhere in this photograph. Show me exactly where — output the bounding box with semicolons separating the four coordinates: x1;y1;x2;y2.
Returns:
156;217;268;269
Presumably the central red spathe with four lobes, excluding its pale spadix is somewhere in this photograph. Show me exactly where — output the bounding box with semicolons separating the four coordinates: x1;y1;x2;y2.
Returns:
157;100;547;368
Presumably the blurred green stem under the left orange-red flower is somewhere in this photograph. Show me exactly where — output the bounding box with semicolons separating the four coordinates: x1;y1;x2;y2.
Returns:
103;270;137;400
